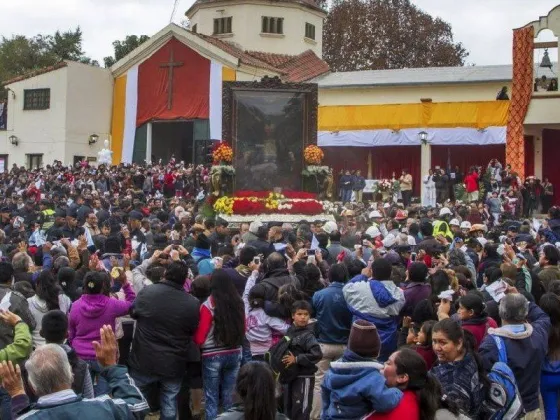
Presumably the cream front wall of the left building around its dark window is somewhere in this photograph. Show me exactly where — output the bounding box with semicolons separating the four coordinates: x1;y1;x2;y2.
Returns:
0;67;68;166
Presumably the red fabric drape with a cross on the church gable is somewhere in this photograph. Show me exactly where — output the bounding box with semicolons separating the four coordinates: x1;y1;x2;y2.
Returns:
136;38;210;127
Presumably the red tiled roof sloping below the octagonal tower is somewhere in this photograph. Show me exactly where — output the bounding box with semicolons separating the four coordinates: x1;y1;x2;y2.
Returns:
193;33;329;82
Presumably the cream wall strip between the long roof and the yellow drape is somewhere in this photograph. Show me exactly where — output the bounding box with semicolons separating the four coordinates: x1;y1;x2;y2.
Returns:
319;82;511;106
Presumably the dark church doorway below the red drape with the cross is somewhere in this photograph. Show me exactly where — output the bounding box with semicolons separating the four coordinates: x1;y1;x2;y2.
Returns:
152;121;194;164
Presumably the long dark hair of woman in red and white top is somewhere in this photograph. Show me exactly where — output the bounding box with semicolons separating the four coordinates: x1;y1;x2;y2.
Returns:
210;269;245;347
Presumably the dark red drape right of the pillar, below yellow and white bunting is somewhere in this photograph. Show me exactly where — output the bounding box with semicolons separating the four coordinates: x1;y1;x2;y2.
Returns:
430;144;506;175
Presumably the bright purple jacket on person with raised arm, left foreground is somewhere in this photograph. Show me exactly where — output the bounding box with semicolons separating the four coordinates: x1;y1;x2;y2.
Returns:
68;283;136;360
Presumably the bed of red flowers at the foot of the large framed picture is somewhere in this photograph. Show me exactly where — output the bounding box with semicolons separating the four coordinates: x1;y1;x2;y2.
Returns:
214;193;324;215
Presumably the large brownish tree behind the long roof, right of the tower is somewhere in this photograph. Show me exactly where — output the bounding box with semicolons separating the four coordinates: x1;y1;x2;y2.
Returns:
323;0;469;71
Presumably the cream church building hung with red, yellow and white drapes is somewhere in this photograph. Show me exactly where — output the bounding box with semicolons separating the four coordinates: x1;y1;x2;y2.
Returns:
0;0;560;199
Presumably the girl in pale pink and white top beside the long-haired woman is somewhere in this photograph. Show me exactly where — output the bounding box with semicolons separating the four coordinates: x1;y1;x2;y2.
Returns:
244;287;290;361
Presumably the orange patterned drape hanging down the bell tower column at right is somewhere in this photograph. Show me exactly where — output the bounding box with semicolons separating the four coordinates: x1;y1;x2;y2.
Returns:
506;25;535;178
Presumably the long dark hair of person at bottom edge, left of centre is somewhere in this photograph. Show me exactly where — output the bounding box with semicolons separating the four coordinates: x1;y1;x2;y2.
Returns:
236;362;276;420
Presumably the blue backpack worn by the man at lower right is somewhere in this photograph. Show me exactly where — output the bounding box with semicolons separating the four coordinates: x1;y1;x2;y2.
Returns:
483;334;525;420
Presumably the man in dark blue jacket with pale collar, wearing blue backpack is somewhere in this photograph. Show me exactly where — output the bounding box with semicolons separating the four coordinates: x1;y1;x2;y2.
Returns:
478;287;551;419
